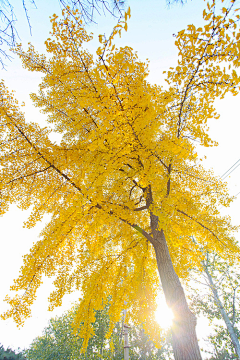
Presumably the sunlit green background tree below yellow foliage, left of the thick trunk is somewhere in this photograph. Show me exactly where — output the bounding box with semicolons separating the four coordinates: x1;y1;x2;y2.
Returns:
25;307;173;360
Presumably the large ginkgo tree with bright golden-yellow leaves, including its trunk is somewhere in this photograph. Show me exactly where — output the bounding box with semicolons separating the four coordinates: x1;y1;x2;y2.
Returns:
0;2;240;360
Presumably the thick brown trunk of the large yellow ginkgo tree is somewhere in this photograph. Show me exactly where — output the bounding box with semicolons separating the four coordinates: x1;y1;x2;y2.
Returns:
151;214;202;360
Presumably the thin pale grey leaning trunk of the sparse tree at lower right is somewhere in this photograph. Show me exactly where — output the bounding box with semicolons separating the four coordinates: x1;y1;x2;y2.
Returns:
205;266;240;359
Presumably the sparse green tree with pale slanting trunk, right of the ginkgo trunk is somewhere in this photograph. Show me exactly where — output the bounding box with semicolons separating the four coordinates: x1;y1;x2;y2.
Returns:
189;252;240;360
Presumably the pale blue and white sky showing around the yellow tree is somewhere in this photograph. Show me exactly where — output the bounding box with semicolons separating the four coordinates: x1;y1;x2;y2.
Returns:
0;0;240;349
